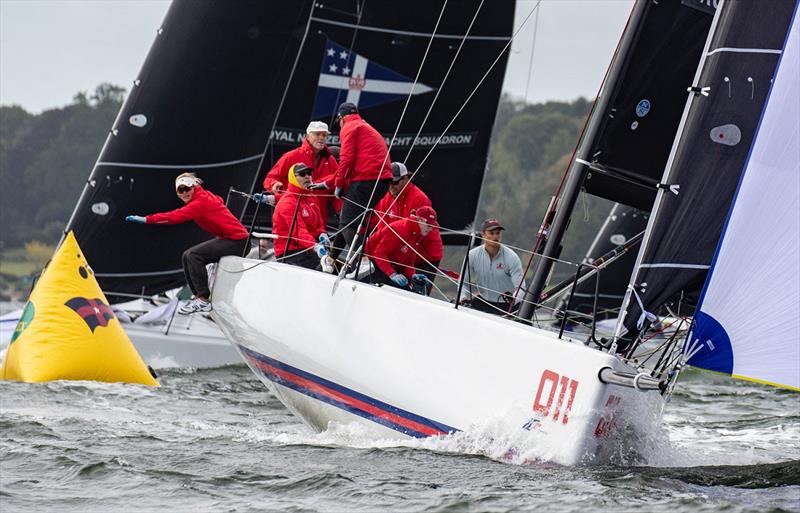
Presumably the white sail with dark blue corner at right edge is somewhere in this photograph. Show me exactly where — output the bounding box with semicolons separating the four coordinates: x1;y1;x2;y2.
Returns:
687;12;800;389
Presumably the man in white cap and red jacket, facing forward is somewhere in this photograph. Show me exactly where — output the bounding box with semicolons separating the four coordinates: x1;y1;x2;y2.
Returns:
254;121;342;221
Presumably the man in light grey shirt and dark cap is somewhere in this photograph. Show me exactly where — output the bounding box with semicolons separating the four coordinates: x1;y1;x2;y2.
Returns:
460;218;525;315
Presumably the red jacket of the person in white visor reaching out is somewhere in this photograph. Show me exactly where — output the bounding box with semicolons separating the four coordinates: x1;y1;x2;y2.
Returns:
145;185;247;240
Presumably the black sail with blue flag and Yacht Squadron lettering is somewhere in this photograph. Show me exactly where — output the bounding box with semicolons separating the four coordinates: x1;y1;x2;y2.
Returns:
247;0;515;242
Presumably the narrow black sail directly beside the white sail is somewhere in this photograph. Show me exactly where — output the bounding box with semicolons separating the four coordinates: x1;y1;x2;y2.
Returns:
624;0;796;342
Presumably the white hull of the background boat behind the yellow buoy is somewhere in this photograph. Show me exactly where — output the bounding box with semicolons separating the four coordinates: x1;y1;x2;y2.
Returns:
0;301;242;369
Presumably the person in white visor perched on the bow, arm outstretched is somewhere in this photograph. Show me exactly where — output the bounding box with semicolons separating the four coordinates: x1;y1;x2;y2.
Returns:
125;173;248;314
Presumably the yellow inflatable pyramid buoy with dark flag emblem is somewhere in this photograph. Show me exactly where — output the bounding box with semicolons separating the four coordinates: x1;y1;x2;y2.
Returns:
0;232;158;386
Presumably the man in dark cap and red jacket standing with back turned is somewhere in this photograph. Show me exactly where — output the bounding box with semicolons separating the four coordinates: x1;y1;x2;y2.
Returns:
334;103;392;254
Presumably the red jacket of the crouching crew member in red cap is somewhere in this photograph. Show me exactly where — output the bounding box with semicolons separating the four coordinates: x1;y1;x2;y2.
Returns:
367;219;422;278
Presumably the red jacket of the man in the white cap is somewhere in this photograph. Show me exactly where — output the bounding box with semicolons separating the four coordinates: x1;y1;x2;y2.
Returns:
264;139;342;215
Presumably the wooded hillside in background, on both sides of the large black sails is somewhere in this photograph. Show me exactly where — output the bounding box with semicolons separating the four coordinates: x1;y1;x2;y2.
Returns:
0;84;609;276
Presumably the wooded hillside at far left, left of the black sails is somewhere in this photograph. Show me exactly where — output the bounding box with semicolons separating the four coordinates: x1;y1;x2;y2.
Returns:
0;84;125;249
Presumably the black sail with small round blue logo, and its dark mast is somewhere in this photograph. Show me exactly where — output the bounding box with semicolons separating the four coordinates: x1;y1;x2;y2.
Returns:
520;0;713;319
